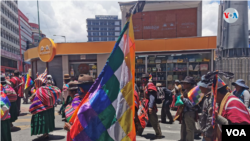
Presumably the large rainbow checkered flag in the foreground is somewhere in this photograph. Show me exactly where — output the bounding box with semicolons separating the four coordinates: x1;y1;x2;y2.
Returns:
70;15;136;141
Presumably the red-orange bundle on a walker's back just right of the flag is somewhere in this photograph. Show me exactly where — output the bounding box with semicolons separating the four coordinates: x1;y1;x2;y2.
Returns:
137;99;148;128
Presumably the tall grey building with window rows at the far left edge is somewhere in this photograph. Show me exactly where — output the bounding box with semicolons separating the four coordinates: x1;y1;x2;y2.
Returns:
0;0;21;73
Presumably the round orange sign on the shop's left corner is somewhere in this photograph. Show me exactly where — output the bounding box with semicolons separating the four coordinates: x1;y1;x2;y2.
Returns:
38;38;56;62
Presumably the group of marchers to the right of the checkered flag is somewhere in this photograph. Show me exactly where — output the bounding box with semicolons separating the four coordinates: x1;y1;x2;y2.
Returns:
135;74;250;141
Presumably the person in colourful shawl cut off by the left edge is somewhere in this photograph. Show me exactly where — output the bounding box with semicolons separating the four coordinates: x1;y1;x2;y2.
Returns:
0;84;11;141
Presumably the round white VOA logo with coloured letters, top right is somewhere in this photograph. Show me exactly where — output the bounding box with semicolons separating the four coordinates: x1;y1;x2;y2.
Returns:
223;8;239;23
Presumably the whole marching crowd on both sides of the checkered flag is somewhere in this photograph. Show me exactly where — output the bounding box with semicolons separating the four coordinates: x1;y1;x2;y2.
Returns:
0;71;250;141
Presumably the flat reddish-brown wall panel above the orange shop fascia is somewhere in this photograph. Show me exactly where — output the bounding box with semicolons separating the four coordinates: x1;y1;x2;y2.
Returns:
133;8;197;39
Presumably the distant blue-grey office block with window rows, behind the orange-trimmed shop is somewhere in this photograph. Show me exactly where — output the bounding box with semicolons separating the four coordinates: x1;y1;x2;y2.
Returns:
87;15;121;42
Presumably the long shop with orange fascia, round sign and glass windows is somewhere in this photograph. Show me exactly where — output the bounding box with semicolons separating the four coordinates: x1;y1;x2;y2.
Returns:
24;37;216;87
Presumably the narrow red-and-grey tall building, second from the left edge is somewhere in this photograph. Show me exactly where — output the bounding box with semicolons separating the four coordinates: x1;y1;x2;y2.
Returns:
18;10;32;73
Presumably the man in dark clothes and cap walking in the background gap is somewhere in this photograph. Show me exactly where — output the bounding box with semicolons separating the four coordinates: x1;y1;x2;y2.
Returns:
156;83;173;124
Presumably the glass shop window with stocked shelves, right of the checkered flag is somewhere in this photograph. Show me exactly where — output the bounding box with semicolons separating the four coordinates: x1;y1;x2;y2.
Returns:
135;50;213;91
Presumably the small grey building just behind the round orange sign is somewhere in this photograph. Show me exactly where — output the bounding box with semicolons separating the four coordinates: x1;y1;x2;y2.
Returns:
29;23;46;47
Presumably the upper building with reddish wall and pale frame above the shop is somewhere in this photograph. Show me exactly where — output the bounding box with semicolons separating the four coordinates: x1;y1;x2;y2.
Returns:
119;0;202;39
